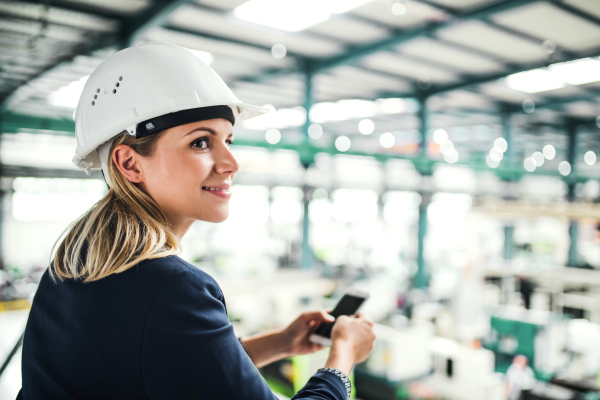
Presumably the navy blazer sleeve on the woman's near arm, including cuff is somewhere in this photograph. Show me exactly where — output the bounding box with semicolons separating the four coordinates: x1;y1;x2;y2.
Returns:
142;270;346;400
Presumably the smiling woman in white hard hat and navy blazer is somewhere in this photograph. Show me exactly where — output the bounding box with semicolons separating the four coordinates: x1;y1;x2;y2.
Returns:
18;43;374;400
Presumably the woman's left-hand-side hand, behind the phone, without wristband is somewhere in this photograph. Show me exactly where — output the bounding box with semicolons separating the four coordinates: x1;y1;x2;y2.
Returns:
281;310;335;356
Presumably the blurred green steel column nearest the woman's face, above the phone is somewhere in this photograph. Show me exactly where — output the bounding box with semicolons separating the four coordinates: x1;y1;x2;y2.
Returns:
300;61;314;269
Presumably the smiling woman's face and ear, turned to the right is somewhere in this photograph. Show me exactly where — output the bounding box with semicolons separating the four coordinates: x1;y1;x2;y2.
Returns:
139;118;239;233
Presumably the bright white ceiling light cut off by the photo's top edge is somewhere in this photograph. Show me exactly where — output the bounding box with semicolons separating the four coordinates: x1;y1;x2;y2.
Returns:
233;0;371;32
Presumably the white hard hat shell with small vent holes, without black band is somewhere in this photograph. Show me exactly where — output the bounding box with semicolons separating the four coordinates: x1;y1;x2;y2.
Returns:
73;43;267;171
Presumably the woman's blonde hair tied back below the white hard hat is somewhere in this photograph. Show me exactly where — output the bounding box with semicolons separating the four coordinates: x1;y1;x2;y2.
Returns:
50;131;180;282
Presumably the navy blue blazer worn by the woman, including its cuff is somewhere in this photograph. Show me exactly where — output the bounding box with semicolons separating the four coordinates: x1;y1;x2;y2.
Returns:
17;256;346;400
